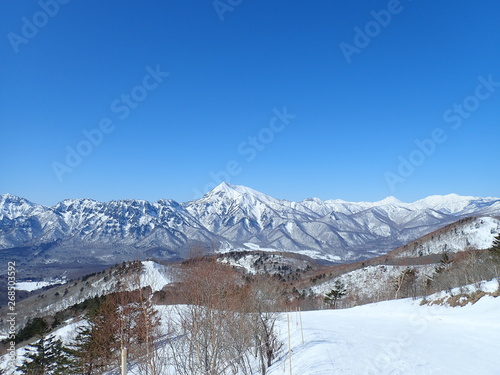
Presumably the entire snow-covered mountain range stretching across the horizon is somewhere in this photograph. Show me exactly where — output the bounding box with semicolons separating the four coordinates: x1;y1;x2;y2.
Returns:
0;183;500;274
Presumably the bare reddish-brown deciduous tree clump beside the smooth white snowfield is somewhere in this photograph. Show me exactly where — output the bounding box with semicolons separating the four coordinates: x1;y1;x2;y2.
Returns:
171;258;279;375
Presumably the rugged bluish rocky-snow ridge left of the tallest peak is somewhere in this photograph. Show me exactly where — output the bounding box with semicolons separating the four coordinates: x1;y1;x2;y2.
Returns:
0;195;218;264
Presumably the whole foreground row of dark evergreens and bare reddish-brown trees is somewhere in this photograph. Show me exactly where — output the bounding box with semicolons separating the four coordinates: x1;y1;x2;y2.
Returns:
14;258;286;375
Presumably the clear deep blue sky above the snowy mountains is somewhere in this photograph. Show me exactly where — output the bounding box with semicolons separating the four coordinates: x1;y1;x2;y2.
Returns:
0;0;500;205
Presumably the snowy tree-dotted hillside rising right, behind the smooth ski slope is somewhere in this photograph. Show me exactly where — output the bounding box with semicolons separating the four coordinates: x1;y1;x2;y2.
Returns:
301;217;500;306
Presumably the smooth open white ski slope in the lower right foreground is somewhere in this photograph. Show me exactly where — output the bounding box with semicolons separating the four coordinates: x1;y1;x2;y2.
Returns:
269;282;500;375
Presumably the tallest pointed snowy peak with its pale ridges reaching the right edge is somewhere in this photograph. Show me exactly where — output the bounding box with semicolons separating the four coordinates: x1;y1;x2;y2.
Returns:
185;183;500;260
